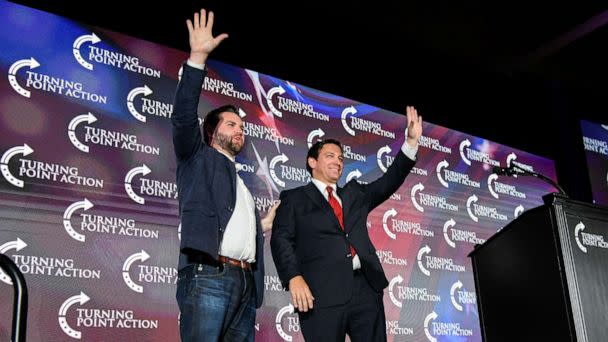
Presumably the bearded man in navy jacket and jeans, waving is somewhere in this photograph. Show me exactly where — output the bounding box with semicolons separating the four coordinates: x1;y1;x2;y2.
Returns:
171;9;276;341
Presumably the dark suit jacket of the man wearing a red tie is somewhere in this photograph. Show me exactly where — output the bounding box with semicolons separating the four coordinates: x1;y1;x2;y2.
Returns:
270;151;415;307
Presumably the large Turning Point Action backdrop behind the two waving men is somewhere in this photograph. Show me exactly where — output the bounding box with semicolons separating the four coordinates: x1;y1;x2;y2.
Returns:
0;1;555;341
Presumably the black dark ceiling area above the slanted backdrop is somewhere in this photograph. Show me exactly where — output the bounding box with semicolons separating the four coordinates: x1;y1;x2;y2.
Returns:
8;0;608;198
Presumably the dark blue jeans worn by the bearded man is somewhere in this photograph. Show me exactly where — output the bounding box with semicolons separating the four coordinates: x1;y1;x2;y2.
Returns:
175;264;255;342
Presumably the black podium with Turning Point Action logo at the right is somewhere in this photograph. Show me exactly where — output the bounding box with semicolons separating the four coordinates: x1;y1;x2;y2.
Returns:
469;194;608;342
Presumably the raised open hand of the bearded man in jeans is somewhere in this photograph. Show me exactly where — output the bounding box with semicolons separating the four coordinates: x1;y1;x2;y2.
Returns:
186;8;228;64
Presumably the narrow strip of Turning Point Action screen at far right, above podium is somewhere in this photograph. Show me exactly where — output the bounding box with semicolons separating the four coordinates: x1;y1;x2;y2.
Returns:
581;120;608;206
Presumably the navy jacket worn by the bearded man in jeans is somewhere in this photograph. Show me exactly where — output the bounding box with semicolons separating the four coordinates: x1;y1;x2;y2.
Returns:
171;64;264;307
